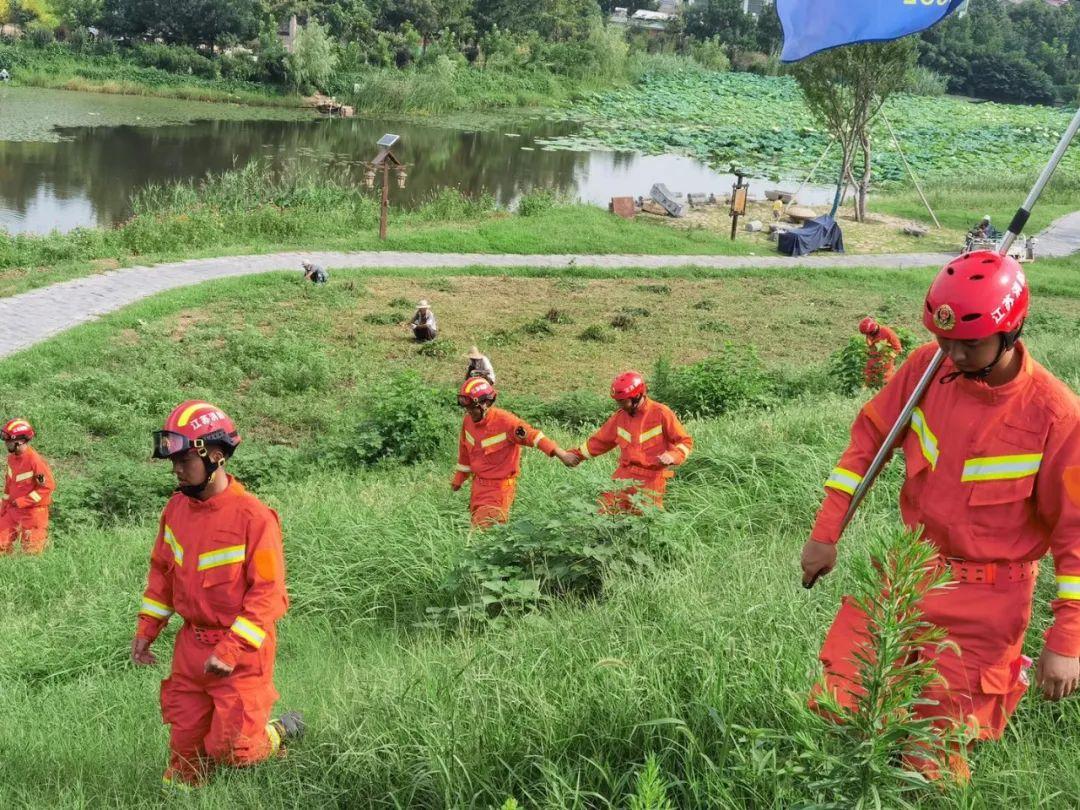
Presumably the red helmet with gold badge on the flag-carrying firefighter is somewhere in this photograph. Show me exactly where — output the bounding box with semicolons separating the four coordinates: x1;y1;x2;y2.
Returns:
922;251;1031;340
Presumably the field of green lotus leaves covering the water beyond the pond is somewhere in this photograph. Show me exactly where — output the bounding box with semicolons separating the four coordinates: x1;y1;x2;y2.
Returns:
544;70;1080;183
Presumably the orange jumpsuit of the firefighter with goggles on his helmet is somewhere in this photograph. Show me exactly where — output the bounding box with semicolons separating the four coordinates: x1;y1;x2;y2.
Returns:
136;478;288;784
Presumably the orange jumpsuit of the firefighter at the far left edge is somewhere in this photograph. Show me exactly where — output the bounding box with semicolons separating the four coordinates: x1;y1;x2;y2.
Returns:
0;446;56;554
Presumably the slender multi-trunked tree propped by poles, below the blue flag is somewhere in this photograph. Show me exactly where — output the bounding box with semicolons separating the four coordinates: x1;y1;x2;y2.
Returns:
794;38;917;221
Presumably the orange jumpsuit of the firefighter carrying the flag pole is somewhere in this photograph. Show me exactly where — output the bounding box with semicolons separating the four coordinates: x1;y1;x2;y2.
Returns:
811;345;1080;739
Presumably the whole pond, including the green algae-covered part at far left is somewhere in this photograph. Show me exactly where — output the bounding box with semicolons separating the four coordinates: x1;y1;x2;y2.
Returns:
0;87;832;233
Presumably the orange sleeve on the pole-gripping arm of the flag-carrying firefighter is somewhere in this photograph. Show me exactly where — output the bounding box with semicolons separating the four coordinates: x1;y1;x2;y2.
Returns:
810;346;935;543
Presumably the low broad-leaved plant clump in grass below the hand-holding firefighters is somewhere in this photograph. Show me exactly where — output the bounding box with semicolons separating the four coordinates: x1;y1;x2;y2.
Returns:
428;487;672;622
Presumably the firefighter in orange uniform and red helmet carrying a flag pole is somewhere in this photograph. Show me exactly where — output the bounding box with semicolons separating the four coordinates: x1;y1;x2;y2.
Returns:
802;252;1080;781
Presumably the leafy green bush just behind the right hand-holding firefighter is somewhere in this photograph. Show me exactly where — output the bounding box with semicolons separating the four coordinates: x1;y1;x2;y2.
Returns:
650;343;774;417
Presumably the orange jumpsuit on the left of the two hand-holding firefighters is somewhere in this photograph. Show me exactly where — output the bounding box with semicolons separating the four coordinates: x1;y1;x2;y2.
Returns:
453;407;556;528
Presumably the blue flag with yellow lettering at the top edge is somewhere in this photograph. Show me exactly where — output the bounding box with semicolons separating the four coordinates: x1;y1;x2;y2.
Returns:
777;0;963;62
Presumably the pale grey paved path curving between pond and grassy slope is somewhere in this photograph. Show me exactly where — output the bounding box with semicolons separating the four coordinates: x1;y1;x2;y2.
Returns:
0;212;1080;357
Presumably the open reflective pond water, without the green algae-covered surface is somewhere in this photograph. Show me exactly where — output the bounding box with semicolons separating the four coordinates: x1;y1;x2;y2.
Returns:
0;109;838;233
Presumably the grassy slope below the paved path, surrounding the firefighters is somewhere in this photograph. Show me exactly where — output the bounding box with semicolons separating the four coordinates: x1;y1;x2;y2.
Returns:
0;261;1080;808
